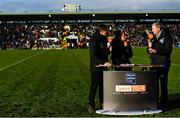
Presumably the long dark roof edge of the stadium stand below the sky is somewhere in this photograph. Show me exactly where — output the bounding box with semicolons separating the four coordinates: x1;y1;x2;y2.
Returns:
0;12;180;20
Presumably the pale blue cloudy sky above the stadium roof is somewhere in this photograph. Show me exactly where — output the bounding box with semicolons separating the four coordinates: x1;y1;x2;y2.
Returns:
0;0;180;12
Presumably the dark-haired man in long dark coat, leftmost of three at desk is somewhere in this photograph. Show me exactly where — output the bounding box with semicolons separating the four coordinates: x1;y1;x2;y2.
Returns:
88;25;111;113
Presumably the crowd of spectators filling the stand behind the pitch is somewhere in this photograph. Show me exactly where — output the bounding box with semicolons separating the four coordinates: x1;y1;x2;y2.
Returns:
0;23;180;49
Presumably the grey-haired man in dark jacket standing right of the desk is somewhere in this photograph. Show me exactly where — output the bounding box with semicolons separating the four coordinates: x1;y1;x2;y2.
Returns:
148;22;173;110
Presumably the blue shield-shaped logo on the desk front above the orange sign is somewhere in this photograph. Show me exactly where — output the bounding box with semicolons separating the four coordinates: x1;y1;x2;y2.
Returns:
125;72;136;84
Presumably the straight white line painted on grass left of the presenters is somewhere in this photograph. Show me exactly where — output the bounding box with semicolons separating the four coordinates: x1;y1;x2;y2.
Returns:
0;52;42;72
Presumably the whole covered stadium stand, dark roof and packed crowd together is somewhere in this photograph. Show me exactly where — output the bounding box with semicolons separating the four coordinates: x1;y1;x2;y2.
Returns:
0;13;180;50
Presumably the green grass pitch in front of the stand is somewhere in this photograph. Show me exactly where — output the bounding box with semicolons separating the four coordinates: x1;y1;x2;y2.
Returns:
0;48;180;117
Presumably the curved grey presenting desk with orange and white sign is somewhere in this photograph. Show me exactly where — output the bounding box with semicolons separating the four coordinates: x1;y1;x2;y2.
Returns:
96;64;163;115
